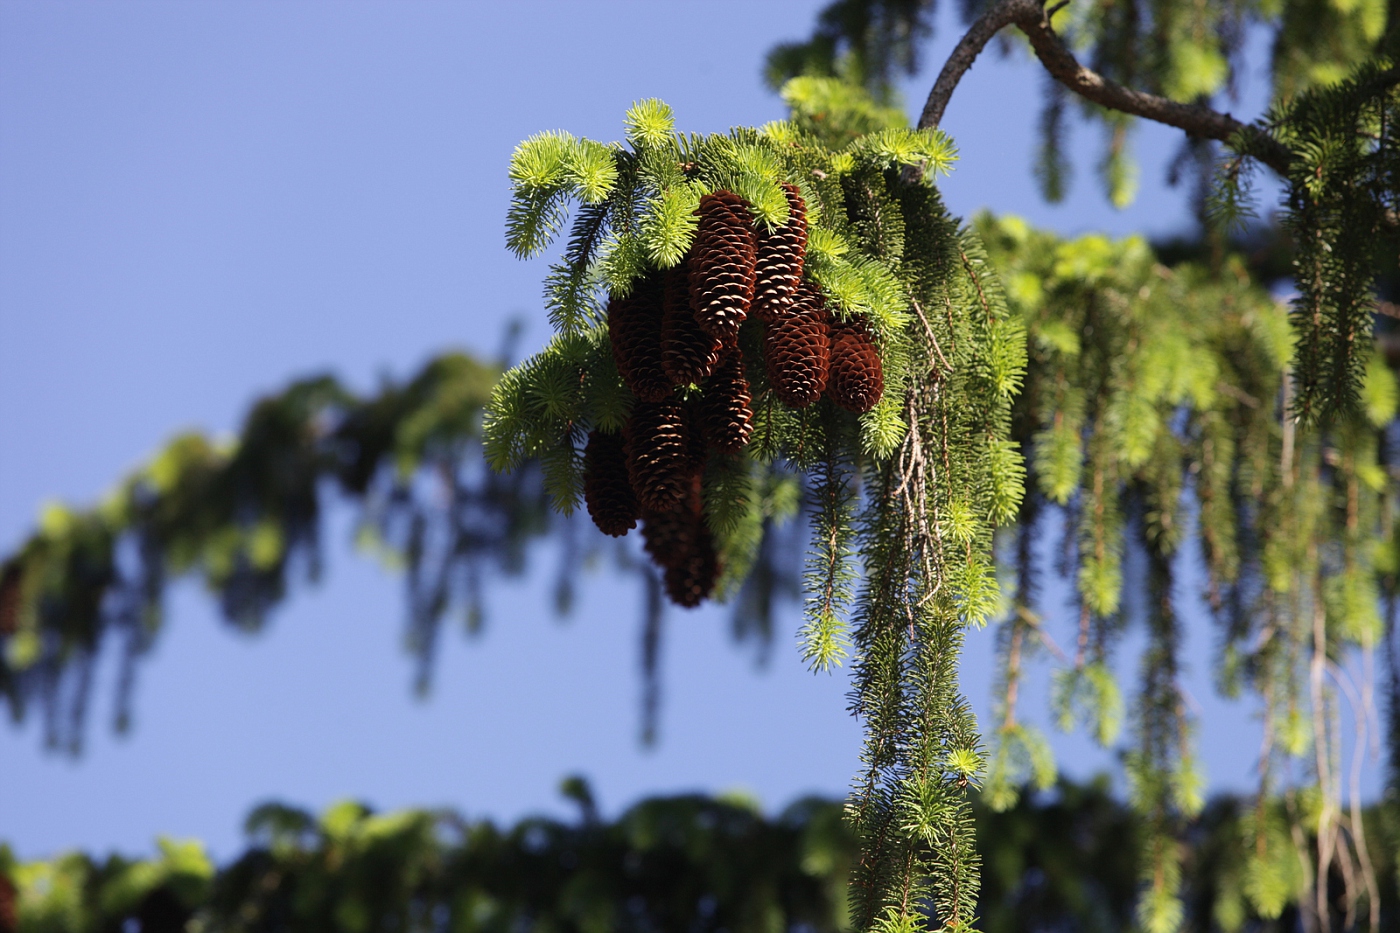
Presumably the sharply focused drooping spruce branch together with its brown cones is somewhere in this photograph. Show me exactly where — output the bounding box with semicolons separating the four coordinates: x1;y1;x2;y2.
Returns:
484;101;1025;929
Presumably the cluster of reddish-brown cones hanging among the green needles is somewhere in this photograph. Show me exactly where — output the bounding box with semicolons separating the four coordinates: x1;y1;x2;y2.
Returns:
584;185;883;607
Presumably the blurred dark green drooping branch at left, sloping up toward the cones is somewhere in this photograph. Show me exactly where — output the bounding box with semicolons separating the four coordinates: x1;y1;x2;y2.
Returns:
0;354;547;749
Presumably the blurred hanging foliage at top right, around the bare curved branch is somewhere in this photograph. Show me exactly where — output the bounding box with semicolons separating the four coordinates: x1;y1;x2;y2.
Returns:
764;0;1400;206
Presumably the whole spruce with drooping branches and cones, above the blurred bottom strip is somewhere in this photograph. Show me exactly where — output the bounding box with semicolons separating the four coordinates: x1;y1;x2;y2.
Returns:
0;0;1400;933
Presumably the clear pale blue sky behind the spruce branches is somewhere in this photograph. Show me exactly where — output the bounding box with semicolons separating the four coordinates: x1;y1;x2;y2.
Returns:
0;0;1310;857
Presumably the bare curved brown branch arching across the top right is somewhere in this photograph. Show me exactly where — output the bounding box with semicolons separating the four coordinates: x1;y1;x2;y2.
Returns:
918;0;1292;175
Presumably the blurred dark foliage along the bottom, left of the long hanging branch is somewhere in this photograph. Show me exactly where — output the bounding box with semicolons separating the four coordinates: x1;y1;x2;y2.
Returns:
17;787;851;933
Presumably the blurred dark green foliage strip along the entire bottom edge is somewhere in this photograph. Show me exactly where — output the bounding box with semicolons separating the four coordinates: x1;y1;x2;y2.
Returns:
0;779;1400;933
